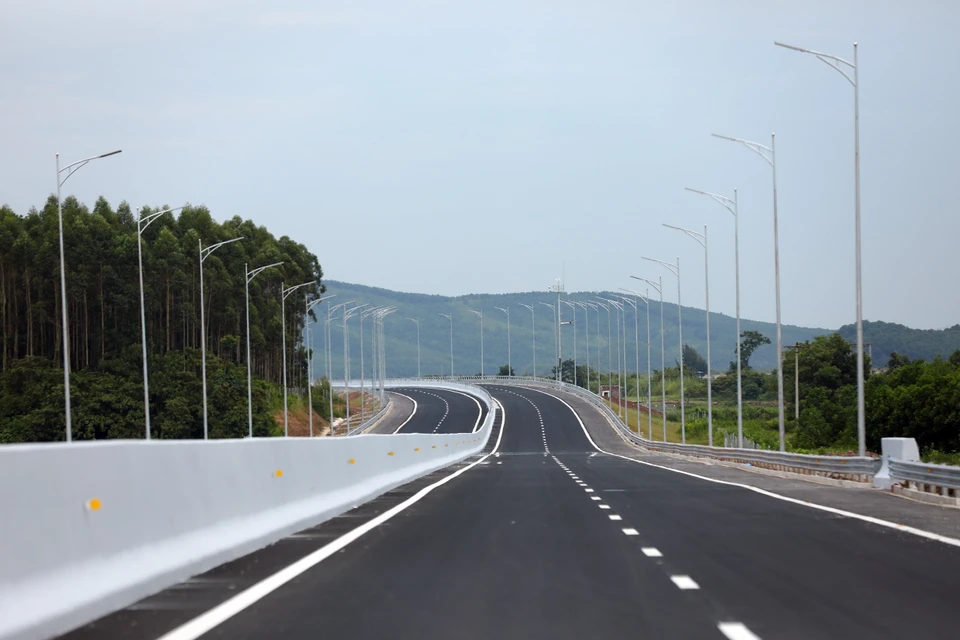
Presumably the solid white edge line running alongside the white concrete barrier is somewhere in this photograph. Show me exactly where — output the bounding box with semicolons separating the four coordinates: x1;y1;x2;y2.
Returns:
158;400;506;640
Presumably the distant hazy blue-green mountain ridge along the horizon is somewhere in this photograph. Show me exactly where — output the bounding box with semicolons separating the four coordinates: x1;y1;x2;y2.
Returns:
313;280;960;377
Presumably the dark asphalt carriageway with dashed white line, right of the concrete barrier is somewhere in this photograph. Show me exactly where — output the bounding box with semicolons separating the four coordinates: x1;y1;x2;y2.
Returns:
65;386;960;640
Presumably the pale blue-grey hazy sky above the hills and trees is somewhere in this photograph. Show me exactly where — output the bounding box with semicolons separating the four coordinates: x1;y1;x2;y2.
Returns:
0;0;960;328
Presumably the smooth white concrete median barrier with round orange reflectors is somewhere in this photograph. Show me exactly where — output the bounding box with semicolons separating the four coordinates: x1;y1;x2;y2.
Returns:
0;383;494;638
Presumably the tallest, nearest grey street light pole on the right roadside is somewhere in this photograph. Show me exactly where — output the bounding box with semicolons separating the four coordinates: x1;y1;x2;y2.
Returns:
774;42;867;457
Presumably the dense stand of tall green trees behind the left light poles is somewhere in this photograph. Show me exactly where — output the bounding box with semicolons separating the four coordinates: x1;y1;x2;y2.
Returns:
0;196;323;442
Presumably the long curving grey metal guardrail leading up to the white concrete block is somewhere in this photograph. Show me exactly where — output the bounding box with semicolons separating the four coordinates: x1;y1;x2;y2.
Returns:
438;376;880;480
